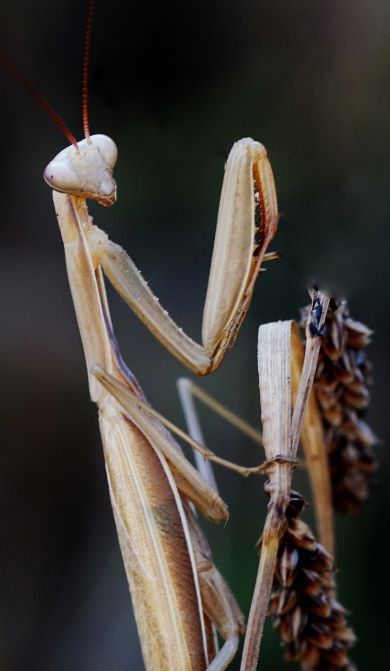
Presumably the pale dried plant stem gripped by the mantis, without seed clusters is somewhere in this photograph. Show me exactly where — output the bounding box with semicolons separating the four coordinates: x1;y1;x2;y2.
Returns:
241;293;329;671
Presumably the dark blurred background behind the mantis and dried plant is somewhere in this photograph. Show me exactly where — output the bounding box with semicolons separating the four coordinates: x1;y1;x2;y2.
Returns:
0;0;390;671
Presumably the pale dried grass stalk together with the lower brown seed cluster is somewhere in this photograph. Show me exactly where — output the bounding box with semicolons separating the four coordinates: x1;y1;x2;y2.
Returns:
241;292;354;671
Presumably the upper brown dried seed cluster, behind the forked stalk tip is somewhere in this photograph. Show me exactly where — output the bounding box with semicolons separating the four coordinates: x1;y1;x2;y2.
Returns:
301;299;377;514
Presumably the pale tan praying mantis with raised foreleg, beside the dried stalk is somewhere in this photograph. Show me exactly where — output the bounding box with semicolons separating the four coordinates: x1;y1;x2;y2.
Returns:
4;3;278;671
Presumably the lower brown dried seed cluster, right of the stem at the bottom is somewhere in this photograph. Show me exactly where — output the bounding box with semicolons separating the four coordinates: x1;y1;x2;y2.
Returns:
270;492;356;671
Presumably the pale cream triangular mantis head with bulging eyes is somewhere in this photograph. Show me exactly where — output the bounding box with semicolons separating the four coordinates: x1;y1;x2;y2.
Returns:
43;135;118;207
